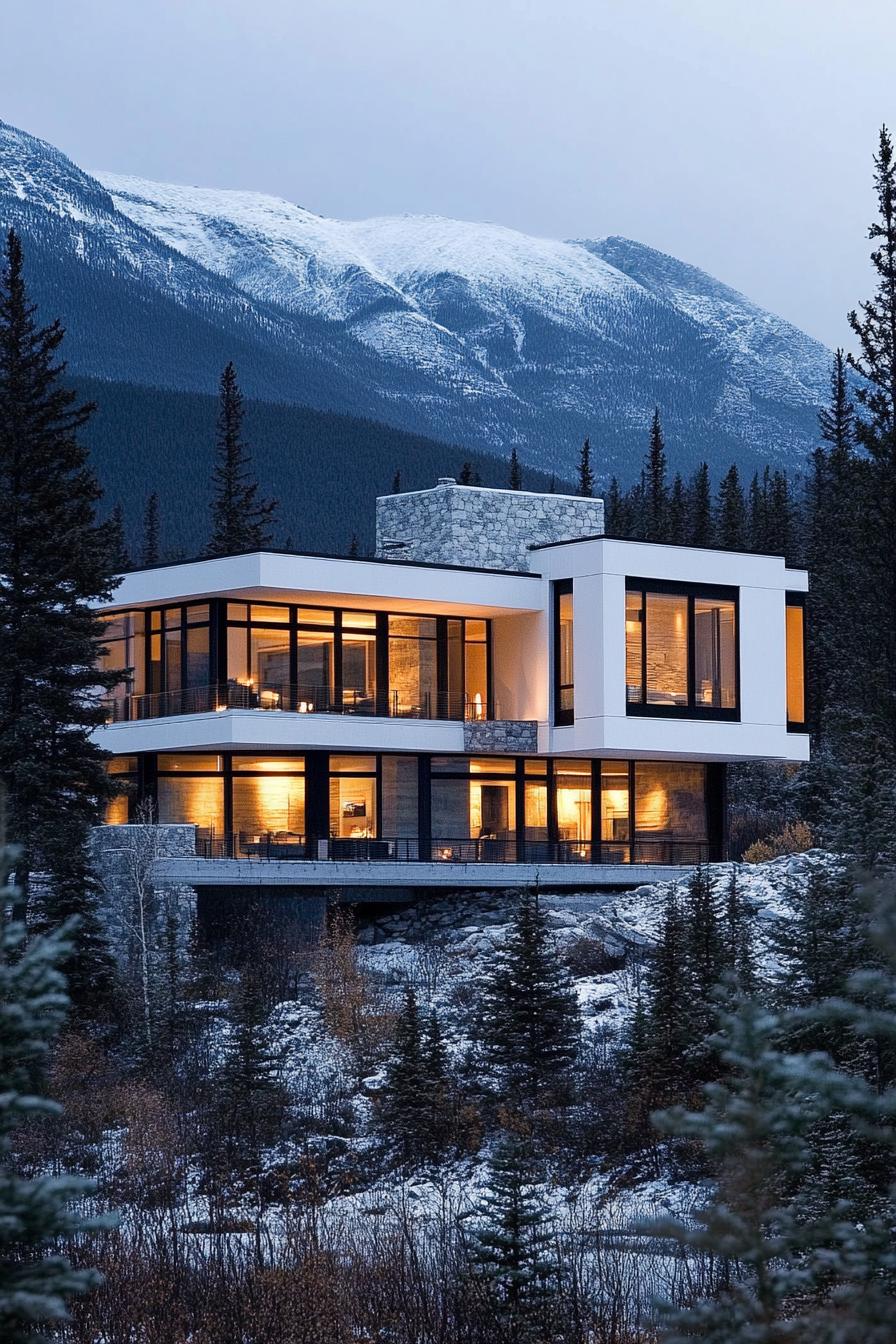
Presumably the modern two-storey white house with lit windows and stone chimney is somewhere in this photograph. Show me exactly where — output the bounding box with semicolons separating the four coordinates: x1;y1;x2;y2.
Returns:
97;478;809;887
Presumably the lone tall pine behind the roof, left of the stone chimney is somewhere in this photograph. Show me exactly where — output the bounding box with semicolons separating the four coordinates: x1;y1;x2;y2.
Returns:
206;363;277;555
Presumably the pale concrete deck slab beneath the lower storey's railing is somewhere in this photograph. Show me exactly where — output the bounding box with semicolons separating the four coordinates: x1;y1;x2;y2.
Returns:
153;857;690;891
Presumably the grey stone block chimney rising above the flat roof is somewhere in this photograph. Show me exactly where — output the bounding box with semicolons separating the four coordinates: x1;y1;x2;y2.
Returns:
376;477;603;570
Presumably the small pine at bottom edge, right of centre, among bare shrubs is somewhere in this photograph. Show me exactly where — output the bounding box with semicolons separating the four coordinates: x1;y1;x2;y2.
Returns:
470;1134;560;1344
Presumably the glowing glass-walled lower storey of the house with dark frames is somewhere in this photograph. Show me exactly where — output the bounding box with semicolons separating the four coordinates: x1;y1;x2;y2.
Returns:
107;750;725;871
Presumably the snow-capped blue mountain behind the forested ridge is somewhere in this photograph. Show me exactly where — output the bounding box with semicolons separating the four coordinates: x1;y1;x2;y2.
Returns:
0;124;830;478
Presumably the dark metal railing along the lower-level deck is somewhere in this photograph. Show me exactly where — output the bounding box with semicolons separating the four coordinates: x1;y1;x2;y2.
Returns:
196;829;709;867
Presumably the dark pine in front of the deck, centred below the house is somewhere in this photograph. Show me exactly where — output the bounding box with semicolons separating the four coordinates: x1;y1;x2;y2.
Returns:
478;891;582;1103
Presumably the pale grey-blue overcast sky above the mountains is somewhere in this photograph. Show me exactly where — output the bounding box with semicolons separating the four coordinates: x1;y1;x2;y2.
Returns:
0;0;896;345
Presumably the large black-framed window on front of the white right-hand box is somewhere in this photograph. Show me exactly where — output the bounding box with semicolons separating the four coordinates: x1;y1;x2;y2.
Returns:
625;579;737;718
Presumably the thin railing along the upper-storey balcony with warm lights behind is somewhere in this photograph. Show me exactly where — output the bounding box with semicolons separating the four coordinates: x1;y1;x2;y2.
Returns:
105;681;501;723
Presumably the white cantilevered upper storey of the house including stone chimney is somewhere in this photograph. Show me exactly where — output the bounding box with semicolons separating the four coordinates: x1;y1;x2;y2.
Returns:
92;481;809;761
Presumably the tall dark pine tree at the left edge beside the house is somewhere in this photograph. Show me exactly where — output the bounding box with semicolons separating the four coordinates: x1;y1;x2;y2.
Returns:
0;231;118;1011
